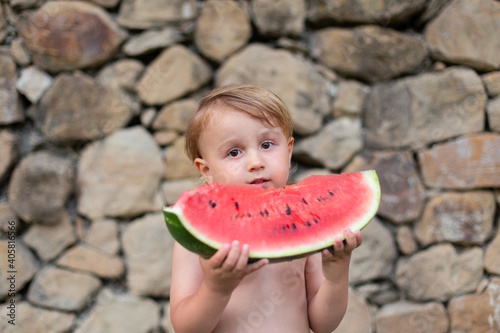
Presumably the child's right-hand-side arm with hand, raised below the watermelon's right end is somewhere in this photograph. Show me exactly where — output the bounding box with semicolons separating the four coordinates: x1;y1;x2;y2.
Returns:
306;230;363;333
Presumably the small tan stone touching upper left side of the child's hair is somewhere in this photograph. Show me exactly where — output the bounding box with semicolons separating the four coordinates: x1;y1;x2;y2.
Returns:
152;98;197;133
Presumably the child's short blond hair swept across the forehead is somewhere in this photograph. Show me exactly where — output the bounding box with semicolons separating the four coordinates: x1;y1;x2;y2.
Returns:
185;85;293;161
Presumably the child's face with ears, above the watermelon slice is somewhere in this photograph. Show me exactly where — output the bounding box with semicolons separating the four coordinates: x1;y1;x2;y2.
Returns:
194;108;293;188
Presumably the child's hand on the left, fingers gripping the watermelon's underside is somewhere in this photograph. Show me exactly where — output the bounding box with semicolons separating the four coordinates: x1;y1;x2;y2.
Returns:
200;241;269;294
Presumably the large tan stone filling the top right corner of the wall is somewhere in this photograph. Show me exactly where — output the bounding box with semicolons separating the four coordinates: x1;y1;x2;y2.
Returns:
424;0;500;71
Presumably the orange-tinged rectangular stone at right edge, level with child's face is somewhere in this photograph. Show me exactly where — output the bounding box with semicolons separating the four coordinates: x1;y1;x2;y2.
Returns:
418;133;500;189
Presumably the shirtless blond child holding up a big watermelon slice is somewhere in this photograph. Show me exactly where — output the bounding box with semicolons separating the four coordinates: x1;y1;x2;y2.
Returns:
170;86;362;333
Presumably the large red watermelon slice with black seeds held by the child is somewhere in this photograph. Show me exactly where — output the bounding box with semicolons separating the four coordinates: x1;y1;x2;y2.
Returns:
163;170;380;262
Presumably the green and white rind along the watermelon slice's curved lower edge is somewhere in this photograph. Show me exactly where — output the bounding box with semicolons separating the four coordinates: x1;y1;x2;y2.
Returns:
163;170;381;262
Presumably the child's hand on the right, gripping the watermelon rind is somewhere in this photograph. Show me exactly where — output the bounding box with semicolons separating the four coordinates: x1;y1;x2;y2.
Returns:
321;229;363;280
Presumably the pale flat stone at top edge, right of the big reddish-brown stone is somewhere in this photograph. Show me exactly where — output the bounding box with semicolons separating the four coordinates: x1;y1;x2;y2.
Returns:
117;0;197;29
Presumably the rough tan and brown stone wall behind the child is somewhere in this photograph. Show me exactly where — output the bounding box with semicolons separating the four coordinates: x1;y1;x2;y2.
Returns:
0;0;500;333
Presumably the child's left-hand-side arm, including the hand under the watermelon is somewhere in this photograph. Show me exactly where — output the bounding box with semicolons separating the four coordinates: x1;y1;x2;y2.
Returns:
170;242;267;333
